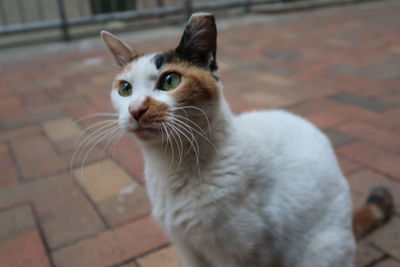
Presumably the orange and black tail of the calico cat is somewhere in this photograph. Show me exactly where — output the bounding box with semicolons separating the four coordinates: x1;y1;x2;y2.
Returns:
353;186;394;240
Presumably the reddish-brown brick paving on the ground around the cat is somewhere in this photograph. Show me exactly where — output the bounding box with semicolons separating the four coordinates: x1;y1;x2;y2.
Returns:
0;1;400;267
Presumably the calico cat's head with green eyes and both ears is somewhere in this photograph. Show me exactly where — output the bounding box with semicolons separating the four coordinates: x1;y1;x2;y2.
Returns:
102;13;222;140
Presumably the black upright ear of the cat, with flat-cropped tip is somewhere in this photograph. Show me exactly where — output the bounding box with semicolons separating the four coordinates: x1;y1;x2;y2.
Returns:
175;13;217;71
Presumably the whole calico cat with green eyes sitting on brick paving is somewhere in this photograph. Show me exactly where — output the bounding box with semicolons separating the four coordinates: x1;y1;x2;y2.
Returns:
102;13;392;267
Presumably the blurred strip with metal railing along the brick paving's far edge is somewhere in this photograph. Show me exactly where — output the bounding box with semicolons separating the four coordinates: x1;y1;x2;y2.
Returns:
0;0;316;45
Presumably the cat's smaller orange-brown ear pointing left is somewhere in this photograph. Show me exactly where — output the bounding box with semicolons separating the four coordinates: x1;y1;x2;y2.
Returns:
101;31;138;67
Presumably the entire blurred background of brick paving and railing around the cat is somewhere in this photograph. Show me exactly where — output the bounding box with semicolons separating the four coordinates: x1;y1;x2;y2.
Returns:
0;0;400;267
